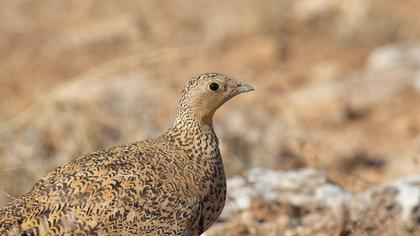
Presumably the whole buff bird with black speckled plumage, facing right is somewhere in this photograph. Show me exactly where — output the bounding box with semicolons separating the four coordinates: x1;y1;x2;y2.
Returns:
0;73;254;235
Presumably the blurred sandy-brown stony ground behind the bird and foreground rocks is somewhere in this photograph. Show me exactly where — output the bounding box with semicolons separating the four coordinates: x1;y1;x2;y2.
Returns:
0;0;420;235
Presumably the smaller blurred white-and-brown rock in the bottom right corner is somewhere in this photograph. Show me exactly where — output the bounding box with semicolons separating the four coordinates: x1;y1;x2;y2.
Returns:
347;176;420;235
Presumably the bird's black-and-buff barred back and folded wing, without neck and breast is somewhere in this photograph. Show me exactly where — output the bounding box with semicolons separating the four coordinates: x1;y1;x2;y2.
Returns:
0;138;210;234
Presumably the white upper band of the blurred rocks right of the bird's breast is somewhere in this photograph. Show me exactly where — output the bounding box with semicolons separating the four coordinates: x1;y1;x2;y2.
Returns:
222;168;420;224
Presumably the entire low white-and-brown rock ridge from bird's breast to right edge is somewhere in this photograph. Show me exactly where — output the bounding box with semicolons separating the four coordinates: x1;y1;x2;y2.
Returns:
206;168;420;235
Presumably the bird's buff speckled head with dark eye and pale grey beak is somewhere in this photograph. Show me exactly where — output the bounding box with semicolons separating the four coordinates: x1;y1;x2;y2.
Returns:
173;73;254;126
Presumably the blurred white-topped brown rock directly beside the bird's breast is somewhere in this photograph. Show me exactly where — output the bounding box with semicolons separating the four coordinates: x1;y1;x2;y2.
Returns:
206;168;350;235
